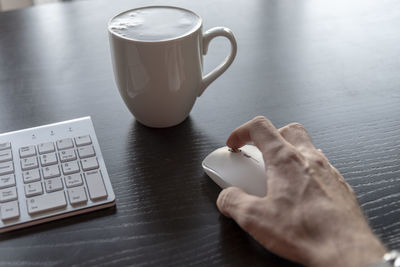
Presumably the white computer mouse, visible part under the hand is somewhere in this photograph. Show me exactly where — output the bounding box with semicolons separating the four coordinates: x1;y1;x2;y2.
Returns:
202;145;267;197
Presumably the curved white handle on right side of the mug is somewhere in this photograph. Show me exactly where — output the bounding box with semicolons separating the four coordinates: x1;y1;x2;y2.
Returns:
198;27;237;96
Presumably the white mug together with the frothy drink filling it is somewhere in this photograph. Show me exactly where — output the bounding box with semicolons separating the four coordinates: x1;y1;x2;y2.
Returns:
108;6;237;127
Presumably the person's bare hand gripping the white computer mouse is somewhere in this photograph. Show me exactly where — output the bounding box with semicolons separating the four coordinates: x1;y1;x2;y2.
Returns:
217;117;385;267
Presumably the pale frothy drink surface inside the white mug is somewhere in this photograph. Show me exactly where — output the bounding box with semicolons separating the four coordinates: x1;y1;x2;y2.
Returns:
108;7;201;41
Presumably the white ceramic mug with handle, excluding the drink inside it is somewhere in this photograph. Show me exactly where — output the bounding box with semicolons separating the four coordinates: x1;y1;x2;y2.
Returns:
108;7;237;127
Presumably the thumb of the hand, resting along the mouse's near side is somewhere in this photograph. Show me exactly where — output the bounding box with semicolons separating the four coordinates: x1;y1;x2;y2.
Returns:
217;187;263;231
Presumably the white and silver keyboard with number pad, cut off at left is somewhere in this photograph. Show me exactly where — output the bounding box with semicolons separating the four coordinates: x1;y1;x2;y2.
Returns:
0;117;115;233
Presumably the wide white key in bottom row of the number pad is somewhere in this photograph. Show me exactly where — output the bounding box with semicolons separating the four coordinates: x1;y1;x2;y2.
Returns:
26;191;67;215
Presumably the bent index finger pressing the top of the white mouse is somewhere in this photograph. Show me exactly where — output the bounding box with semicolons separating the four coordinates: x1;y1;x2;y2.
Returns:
226;116;290;161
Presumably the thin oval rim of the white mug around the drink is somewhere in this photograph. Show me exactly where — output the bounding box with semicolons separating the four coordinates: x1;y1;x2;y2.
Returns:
107;5;203;44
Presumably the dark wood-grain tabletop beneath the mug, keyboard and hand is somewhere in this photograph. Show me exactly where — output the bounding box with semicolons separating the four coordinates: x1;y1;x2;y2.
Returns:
0;0;400;266
